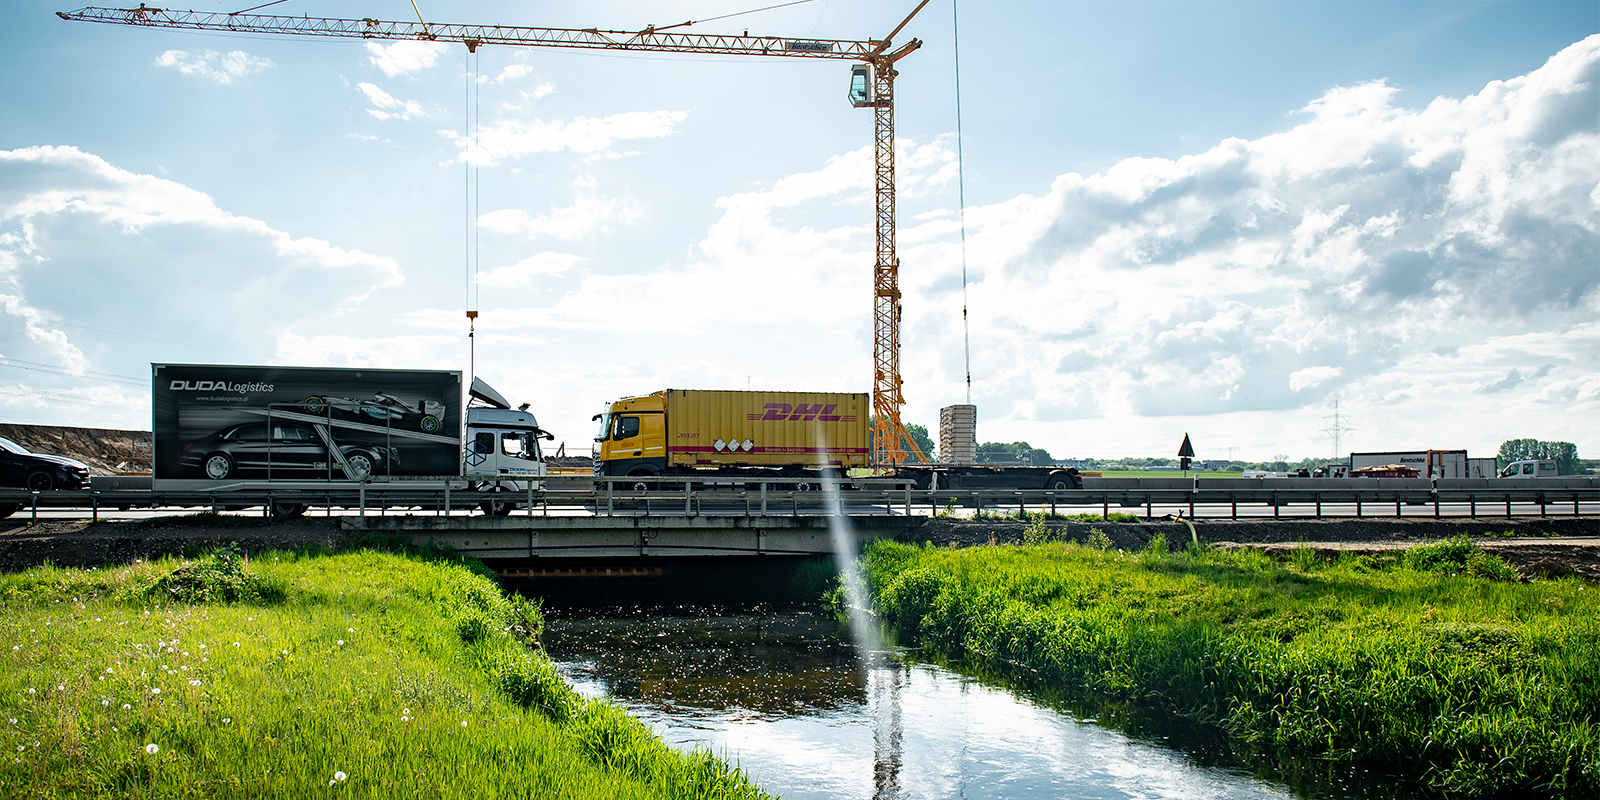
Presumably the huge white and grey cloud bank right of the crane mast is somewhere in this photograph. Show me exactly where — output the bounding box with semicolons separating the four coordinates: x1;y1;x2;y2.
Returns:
901;35;1600;451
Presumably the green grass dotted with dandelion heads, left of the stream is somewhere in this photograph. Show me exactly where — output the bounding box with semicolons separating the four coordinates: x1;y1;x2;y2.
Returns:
0;550;765;798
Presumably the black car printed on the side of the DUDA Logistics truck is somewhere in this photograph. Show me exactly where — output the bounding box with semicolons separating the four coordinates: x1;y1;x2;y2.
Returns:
181;422;398;480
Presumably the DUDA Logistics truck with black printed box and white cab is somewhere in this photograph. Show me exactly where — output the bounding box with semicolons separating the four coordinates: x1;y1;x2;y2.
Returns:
150;363;554;515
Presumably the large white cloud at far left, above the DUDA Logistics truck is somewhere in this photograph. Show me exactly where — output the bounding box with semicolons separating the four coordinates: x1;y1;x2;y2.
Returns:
0;147;403;427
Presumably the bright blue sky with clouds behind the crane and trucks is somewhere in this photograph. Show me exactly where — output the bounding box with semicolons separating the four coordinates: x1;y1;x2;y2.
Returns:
0;0;1600;461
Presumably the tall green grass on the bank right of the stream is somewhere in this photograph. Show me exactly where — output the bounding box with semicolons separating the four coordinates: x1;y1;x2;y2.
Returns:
864;541;1600;798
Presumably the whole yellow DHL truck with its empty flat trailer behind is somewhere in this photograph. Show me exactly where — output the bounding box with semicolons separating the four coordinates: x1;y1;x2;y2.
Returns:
592;389;1083;491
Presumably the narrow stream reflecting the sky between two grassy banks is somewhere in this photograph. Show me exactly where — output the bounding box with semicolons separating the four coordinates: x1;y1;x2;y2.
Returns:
544;613;1344;800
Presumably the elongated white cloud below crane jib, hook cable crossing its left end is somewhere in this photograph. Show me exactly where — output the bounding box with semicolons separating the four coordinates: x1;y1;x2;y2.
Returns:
442;110;688;166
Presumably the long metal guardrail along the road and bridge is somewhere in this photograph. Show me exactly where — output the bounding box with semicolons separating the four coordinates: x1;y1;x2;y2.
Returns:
0;477;1600;520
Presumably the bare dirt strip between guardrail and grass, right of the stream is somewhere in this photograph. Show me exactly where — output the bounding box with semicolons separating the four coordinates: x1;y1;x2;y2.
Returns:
901;517;1600;579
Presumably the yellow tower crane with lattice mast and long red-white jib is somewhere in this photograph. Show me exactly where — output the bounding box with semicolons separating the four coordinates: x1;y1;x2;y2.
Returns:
56;0;928;467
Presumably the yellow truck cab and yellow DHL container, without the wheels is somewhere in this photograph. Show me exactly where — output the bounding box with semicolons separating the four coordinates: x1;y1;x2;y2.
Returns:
595;389;870;475
